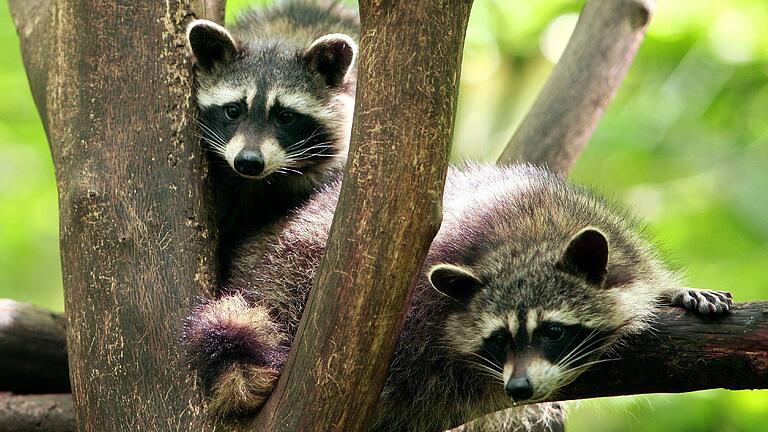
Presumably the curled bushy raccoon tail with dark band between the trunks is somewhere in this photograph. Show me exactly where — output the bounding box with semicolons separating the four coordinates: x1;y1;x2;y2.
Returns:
182;294;287;417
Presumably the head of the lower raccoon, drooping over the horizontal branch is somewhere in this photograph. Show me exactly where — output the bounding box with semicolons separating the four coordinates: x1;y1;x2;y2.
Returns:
429;228;621;403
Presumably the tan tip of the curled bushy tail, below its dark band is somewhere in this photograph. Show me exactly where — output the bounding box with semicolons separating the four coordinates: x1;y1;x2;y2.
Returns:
208;364;280;418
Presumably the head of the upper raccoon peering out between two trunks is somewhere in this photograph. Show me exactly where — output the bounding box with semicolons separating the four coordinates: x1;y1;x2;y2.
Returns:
187;20;357;179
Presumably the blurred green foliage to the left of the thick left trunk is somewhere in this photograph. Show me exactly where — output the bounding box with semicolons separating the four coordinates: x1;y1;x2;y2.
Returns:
0;1;64;310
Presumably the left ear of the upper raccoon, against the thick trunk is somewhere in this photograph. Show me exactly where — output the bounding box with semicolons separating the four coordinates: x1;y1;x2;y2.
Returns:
187;20;238;70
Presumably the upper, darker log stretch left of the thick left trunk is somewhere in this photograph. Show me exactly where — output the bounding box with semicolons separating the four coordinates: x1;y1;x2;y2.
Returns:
0;299;70;394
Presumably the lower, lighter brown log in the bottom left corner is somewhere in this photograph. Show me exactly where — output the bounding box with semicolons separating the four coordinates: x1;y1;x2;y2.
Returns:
0;393;75;432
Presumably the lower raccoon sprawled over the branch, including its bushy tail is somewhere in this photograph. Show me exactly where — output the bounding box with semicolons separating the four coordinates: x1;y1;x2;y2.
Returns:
184;165;732;431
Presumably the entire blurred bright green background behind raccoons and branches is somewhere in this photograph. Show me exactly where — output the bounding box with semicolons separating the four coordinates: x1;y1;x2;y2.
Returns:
0;0;768;432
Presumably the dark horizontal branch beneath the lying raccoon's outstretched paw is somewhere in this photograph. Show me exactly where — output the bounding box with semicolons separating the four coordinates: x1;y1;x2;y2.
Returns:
557;301;768;400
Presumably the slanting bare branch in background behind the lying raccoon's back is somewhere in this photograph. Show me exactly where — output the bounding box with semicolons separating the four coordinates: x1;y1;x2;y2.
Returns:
499;0;656;173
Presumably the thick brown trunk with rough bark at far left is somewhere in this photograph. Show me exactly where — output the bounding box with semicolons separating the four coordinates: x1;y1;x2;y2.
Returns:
10;0;223;431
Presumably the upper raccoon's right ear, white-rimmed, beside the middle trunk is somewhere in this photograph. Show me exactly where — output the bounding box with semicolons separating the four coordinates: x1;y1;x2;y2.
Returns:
301;33;357;87
